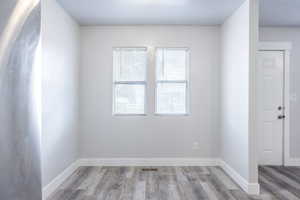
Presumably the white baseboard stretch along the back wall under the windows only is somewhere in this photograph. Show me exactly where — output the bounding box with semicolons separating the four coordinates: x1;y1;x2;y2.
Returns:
78;158;219;166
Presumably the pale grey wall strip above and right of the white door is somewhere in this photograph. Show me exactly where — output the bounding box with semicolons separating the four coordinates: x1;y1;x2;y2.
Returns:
259;27;300;158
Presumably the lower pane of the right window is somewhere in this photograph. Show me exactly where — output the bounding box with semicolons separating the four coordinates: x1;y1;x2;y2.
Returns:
157;83;186;114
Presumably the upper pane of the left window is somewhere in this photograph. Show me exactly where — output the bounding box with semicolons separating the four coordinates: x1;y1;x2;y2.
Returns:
114;48;147;81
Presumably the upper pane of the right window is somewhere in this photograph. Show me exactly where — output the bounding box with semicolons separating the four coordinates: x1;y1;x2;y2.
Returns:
156;49;187;80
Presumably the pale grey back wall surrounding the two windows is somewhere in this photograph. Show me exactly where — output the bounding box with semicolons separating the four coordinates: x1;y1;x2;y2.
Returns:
80;26;220;158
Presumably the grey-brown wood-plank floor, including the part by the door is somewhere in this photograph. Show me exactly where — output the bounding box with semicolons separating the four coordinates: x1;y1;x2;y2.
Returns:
48;167;300;200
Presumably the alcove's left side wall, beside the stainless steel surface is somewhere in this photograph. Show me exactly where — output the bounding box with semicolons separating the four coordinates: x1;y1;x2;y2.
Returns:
42;0;80;186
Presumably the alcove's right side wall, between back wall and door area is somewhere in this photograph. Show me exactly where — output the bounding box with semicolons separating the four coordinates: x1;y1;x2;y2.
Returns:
220;1;252;182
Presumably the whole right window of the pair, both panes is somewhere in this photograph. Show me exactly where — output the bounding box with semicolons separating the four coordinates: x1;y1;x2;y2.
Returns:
156;48;189;115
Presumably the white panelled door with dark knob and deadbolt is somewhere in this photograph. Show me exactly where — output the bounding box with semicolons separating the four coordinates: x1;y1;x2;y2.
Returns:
257;51;285;165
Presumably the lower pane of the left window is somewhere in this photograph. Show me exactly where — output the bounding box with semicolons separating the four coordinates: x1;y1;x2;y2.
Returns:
115;84;145;114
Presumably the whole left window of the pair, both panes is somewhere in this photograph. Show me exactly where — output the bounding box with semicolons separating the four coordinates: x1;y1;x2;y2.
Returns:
113;48;147;115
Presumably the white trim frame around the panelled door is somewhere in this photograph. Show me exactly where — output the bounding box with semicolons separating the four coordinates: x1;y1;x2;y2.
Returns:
256;42;292;166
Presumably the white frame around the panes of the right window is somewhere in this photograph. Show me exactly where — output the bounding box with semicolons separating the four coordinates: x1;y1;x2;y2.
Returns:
155;47;191;116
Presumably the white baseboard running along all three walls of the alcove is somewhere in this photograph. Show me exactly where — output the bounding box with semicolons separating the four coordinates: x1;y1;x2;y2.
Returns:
43;158;259;199
